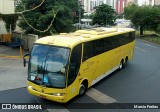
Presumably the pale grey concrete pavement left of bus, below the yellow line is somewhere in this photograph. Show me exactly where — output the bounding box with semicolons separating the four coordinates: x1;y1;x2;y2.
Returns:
0;58;27;91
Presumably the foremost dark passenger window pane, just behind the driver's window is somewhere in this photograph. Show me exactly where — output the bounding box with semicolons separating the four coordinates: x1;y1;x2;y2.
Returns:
83;42;94;61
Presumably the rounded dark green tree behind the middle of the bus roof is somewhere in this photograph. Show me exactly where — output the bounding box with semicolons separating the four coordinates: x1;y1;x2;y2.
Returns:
92;4;116;26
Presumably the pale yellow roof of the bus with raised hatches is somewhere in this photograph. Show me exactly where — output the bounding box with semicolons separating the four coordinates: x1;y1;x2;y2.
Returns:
35;27;135;48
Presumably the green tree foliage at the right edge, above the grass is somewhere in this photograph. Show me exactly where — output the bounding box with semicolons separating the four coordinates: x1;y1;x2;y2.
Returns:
124;5;160;35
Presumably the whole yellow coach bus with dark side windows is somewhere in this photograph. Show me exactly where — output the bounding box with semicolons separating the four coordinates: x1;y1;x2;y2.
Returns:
24;27;135;103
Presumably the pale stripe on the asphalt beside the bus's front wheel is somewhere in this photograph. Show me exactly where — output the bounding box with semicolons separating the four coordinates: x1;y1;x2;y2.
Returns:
86;88;116;103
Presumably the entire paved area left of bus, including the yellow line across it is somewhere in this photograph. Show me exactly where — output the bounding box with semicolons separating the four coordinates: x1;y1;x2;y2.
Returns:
0;45;27;91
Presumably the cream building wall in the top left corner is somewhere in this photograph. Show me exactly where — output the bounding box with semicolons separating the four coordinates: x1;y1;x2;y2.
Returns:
0;0;15;14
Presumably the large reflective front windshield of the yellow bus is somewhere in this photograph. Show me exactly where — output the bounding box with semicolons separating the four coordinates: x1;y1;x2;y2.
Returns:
28;45;70;88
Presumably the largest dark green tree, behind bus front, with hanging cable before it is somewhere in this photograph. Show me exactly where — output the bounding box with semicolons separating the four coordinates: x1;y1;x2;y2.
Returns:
17;0;81;36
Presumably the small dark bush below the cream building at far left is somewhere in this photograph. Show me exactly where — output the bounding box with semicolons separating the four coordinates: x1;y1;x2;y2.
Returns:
2;14;18;31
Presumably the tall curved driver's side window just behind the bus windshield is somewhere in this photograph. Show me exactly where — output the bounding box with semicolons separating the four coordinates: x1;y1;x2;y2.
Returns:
68;44;82;86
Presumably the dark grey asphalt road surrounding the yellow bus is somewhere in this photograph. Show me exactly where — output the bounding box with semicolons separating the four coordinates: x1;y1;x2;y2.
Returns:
0;39;160;112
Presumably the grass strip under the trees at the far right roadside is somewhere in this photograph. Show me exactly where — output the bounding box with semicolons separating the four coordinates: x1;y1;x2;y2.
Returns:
136;31;160;45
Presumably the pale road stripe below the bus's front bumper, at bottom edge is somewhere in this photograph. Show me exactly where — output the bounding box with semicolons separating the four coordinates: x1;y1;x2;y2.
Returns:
35;98;70;112
